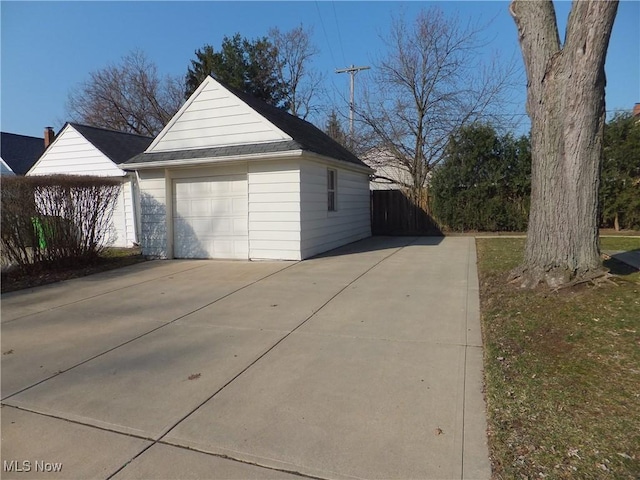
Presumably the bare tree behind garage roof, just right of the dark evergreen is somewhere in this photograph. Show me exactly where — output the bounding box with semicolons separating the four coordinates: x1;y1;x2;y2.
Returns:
269;25;322;119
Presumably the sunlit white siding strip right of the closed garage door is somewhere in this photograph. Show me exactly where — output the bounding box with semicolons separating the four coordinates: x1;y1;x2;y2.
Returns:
248;161;301;260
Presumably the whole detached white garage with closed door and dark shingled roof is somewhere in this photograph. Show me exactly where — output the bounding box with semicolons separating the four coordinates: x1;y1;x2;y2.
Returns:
125;77;371;260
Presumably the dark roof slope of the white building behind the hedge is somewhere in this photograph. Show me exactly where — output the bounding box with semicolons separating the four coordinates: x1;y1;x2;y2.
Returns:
65;122;153;165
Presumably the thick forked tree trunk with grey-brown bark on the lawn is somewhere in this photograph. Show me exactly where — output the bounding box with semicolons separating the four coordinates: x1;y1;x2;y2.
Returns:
510;0;618;287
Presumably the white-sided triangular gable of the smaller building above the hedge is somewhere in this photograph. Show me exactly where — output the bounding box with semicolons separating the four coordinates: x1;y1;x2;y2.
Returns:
27;125;125;177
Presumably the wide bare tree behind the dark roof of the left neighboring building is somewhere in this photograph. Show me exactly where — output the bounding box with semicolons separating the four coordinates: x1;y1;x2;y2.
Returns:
67;51;184;136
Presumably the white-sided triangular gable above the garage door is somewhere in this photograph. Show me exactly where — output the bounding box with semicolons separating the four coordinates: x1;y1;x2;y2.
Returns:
147;77;291;152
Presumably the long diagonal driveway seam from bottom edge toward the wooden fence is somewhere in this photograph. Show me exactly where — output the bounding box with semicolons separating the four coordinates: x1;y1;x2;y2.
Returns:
107;238;417;480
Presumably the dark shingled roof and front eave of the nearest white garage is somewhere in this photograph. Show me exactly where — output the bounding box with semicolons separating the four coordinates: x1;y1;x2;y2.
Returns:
127;77;367;171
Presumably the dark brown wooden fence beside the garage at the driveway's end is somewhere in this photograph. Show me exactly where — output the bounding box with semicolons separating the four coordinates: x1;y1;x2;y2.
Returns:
371;190;442;235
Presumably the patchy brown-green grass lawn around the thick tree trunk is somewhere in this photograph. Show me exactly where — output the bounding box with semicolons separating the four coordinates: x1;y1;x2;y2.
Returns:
476;238;640;480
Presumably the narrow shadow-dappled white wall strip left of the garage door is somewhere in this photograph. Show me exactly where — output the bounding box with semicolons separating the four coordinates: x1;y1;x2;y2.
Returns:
139;170;167;258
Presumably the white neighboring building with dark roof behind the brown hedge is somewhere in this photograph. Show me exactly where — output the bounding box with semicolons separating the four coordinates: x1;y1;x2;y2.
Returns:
27;123;153;247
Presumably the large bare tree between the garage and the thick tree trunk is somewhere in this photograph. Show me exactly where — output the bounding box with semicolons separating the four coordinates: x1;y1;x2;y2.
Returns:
354;7;514;202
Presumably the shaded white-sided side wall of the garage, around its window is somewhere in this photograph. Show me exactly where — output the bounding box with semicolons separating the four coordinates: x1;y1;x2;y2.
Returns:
300;161;371;258
